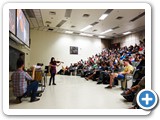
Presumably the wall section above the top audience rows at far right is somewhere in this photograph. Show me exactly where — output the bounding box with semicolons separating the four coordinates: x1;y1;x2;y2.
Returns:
111;31;145;47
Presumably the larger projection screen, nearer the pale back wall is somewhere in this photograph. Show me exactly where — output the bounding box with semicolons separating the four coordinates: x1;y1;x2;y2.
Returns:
17;9;30;47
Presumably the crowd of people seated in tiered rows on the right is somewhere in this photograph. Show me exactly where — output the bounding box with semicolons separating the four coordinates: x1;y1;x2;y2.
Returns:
54;42;145;108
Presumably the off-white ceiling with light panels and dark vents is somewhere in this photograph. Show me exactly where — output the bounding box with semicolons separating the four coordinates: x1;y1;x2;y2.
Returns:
23;9;145;38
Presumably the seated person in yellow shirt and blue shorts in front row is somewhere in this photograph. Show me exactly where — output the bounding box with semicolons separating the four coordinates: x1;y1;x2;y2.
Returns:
105;59;134;88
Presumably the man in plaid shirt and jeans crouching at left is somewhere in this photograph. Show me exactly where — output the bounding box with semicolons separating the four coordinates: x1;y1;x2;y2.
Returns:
11;60;39;103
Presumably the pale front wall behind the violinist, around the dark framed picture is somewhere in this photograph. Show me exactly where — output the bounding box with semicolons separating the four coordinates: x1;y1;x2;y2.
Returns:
30;30;101;69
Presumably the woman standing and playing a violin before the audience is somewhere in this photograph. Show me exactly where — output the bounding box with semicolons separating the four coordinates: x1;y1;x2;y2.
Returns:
49;57;63;86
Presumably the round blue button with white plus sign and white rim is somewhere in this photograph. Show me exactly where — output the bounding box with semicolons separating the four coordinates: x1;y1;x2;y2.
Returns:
137;89;157;110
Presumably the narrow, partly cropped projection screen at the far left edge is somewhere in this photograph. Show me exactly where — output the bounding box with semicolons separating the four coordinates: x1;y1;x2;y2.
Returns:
9;9;16;35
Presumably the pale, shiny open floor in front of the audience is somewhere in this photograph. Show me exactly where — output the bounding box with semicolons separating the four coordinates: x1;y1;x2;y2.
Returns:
9;75;132;109
